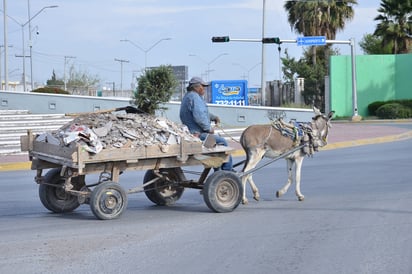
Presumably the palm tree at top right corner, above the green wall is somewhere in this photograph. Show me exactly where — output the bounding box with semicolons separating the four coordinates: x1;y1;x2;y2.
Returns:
374;0;412;54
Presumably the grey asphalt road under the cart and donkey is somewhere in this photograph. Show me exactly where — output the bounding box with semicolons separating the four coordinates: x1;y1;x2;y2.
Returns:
0;139;412;274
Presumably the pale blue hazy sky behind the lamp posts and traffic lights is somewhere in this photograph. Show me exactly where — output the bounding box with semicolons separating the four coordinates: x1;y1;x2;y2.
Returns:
0;0;380;91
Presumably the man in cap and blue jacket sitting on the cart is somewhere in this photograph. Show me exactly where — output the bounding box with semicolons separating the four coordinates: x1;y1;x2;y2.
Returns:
180;77;233;170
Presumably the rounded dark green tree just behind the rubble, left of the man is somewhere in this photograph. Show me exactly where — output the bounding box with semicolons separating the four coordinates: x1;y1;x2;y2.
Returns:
133;66;177;114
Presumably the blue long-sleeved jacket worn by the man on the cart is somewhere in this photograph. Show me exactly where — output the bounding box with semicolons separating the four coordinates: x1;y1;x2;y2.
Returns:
180;91;216;134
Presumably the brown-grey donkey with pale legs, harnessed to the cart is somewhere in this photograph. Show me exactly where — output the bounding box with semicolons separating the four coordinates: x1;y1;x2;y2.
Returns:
240;107;334;204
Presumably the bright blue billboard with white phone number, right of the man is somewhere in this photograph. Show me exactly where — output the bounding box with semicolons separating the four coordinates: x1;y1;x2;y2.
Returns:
211;80;248;106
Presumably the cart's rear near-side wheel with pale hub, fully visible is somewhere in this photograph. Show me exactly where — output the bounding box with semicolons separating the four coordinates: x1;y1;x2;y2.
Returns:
90;182;127;220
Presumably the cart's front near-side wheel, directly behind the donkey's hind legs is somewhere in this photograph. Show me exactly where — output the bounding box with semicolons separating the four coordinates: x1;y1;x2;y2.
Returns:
203;170;242;213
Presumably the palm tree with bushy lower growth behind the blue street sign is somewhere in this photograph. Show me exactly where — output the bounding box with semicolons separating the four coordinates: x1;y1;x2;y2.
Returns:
282;0;357;109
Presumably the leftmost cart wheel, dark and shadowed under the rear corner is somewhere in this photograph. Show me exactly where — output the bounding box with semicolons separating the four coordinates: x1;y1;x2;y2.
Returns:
39;168;82;213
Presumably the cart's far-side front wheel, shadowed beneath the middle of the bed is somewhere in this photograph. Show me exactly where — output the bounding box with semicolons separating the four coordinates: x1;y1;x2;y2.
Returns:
143;168;185;206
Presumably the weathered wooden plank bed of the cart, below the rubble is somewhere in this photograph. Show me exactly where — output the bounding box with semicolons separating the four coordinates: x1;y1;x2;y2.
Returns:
21;131;233;174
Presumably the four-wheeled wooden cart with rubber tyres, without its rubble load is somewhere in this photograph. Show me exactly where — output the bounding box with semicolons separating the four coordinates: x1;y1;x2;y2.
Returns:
21;130;242;220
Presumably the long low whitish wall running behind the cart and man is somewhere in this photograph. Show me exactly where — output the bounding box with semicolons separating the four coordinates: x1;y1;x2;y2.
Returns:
0;91;313;127
